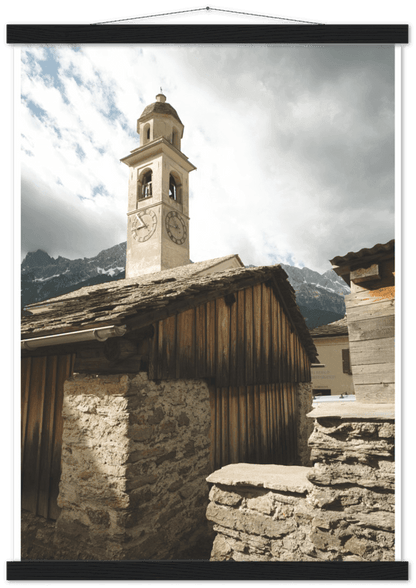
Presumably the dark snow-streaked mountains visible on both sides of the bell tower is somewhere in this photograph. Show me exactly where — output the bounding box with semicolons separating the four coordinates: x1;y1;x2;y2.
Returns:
21;242;350;329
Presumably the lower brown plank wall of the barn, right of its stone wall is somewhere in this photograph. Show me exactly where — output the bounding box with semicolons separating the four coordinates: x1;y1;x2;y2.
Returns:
210;383;297;470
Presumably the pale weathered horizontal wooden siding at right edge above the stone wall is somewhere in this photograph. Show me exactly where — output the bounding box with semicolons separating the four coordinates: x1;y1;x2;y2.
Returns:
345;282;395;403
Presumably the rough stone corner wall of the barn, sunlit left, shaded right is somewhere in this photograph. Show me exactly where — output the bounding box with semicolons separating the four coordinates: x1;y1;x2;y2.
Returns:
22;373;210;560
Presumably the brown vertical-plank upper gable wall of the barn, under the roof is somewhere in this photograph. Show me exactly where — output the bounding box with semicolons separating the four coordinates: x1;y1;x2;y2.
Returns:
149;283;311;387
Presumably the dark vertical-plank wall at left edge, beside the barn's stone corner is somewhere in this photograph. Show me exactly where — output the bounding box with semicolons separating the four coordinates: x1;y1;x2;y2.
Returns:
21;354;74;519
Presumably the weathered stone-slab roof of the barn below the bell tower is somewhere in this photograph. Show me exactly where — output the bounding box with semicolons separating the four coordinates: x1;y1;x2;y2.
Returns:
22;255;317;362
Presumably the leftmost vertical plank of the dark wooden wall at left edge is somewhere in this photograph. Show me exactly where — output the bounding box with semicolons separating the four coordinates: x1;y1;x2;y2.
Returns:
22;357;46;514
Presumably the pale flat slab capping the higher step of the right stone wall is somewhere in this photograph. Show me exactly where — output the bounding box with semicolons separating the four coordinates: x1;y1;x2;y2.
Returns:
307;402;394;420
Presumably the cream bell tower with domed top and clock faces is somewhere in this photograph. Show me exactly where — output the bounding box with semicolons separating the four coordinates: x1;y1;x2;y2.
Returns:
121;94;196;278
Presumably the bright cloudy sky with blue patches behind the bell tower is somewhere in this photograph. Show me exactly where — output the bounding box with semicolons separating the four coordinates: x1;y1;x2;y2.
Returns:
18;45;394;272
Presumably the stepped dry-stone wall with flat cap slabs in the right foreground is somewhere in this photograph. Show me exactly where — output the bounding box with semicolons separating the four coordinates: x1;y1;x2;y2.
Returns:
207;403;395;561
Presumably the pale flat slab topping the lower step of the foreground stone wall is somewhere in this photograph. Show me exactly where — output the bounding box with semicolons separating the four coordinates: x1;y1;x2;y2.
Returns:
207;463;312;493
